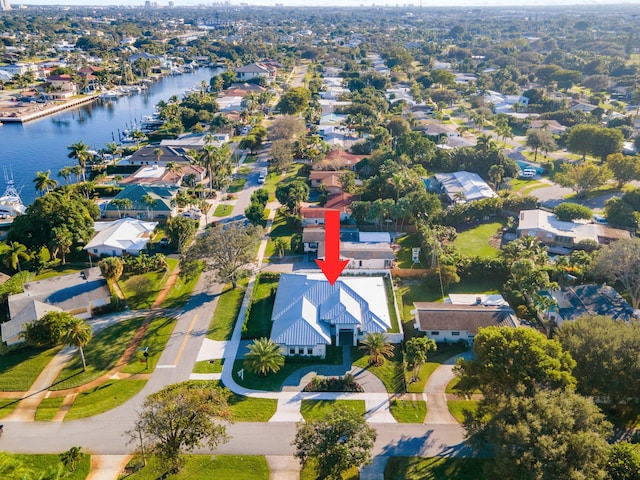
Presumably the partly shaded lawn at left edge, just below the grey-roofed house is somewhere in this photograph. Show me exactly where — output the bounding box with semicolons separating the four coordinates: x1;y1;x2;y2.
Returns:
0;347;60;392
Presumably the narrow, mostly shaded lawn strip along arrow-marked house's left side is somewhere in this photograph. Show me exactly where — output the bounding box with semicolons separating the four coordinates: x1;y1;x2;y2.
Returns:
242;273;280;339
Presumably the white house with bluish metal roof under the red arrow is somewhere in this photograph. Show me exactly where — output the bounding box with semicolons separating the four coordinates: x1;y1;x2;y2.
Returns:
271;274;391;358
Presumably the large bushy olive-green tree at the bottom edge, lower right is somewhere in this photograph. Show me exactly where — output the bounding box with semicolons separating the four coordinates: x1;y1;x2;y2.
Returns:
465;388;612;480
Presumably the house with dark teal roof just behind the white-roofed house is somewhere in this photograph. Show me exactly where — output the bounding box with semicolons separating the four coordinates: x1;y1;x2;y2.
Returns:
104;185;178;223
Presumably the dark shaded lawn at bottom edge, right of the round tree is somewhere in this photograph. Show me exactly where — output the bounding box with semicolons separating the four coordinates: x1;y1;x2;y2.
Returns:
384;457;488;480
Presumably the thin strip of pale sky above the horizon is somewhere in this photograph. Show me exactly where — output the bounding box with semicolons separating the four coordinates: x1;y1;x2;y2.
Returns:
9;0;640;8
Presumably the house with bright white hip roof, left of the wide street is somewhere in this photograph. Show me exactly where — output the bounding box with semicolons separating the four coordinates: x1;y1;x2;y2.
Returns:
84;217;158;257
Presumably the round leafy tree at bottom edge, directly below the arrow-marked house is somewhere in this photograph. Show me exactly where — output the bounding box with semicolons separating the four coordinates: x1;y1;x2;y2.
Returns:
293;406;377;480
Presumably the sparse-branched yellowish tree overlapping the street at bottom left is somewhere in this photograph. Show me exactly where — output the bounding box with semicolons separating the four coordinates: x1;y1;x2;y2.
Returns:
127;381;231;473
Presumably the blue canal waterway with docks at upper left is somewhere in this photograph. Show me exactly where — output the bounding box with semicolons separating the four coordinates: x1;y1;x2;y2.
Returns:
0;68;219;205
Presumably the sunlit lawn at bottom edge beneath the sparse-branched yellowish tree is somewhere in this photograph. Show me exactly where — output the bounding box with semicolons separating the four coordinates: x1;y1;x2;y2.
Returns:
126;455;269;480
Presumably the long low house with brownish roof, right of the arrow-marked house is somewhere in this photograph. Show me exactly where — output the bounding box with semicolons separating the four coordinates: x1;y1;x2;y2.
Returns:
412;302;520;344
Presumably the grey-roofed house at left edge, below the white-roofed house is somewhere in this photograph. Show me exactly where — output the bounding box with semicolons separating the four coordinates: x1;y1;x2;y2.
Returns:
0;267;111;345
